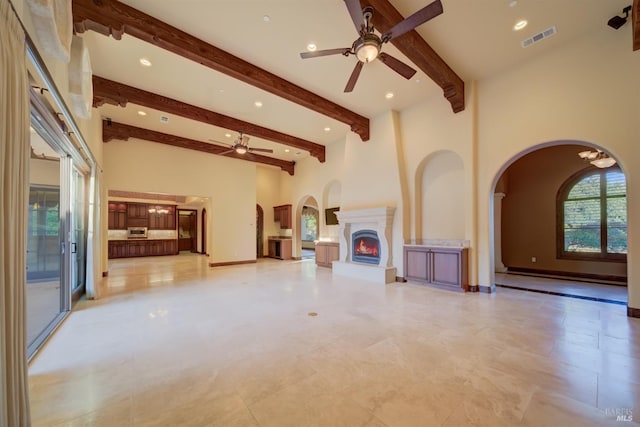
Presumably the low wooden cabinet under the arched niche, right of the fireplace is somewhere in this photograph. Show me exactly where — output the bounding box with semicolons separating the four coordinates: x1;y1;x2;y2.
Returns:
404;245;469;292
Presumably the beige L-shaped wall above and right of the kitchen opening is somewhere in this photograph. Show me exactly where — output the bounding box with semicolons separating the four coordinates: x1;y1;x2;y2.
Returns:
104;139;256;263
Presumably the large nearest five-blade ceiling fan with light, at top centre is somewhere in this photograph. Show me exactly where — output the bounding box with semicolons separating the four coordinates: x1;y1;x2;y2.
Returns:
300;0;442;92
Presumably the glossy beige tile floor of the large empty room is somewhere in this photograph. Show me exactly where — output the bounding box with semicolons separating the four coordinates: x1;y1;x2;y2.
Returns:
30;256;640;427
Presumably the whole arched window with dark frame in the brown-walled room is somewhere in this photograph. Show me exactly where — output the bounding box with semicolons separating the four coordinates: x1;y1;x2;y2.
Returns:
557;168;627;261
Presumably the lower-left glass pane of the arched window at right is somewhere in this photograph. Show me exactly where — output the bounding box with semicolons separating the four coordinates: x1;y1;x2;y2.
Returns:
564;199;601;252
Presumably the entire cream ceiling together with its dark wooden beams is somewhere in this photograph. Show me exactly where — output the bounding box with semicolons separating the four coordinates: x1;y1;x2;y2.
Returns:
73;0;640;174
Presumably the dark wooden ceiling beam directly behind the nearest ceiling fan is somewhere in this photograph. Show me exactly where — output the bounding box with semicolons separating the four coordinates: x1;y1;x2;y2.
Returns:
360;0;462;113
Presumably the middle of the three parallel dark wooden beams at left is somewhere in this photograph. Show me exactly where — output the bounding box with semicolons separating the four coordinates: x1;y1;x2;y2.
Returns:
93;76;325;163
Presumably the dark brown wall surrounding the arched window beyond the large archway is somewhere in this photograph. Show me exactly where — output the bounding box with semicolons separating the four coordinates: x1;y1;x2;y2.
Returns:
502;145;627;276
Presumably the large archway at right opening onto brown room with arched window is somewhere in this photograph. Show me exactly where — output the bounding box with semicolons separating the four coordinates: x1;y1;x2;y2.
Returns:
490;141;628;304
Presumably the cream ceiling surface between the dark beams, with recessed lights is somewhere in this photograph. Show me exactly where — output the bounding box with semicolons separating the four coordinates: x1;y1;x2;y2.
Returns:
82;0;631;165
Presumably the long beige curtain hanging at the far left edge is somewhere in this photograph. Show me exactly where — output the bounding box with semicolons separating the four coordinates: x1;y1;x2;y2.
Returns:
0;0;30;427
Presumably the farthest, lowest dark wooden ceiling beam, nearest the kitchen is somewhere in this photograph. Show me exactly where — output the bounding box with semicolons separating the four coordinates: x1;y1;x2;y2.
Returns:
102;120;296;175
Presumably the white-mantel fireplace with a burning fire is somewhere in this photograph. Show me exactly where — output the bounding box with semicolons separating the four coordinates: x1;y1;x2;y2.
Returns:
333;206;396;284
